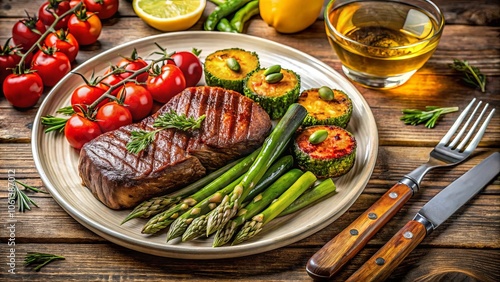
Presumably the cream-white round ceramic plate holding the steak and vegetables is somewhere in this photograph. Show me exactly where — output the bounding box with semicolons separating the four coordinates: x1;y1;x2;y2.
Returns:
32;32;378;259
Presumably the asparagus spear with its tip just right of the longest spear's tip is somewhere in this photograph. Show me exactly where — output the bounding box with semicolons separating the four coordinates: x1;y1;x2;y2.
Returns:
213;169;303;247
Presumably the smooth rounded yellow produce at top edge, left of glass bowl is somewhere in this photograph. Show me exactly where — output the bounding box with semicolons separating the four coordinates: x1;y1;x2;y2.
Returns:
259;0;324;33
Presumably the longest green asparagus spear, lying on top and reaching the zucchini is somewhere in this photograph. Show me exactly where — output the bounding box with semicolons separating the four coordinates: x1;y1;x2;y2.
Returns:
207;103;307;234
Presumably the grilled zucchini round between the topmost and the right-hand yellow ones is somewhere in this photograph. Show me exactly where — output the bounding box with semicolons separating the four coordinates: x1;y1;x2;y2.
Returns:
243;69;300;119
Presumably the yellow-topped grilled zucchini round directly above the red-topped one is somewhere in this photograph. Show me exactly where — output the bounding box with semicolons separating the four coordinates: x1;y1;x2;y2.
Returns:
299;87;352;128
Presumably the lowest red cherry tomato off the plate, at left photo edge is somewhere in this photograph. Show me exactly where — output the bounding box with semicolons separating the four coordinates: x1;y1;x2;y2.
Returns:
3;72;43;108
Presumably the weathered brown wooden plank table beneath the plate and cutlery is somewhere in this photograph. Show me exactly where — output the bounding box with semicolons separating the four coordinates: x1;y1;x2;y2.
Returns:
0;0;500;281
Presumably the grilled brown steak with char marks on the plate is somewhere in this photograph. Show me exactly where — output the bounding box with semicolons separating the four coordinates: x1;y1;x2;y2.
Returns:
79;86;271;209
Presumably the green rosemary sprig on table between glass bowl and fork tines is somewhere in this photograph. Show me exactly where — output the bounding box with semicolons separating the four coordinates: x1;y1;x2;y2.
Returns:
401;106;458;128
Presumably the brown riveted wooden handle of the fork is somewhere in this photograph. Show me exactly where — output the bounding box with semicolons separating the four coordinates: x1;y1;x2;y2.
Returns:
306;183;413;279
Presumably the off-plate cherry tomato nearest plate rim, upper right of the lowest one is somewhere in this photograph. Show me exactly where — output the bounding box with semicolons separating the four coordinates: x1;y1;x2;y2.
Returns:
31;47;71;87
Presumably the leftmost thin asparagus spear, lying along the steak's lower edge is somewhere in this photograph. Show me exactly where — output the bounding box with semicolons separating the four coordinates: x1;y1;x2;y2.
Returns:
121;158;243;224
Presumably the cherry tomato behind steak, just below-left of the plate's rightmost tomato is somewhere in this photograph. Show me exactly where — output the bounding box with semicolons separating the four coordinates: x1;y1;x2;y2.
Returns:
146;64;186;103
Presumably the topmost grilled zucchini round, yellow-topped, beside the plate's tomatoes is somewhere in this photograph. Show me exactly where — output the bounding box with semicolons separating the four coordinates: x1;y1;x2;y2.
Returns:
203;48;260;93
